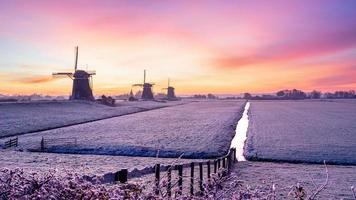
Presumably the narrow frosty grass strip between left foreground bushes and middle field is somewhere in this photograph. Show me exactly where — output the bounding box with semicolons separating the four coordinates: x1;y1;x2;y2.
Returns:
0;150;203;176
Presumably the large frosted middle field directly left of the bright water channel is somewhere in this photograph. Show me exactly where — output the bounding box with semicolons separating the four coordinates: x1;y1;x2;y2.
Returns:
9;101;245;158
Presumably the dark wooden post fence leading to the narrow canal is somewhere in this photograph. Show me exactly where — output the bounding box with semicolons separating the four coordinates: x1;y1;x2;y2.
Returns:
115;148;237;197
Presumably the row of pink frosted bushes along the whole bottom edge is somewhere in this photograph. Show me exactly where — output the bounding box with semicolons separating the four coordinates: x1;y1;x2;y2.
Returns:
0;169;350;200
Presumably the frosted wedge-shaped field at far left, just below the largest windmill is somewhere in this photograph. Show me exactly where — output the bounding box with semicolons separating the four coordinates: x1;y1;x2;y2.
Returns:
0;101;188;138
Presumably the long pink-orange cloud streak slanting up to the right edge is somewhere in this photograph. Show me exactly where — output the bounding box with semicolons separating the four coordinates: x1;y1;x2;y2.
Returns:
212;28;356;68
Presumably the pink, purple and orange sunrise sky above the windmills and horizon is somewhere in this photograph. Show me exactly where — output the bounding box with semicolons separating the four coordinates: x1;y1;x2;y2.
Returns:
0;0;356;95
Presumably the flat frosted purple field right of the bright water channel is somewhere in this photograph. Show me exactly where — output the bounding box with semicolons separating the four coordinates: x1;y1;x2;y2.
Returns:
245;100;356;164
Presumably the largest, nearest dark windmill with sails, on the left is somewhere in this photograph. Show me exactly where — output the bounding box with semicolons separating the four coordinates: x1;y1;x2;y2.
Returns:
52;47;96;101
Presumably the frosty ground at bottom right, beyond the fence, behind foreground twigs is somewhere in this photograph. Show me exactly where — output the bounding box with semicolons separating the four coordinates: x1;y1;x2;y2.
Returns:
224;162;356;199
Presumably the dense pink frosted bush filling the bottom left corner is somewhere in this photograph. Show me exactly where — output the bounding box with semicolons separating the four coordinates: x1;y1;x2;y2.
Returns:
0;169;142;199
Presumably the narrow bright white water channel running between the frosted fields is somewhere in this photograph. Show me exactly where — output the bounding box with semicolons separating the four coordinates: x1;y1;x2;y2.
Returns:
231;102;250;161
